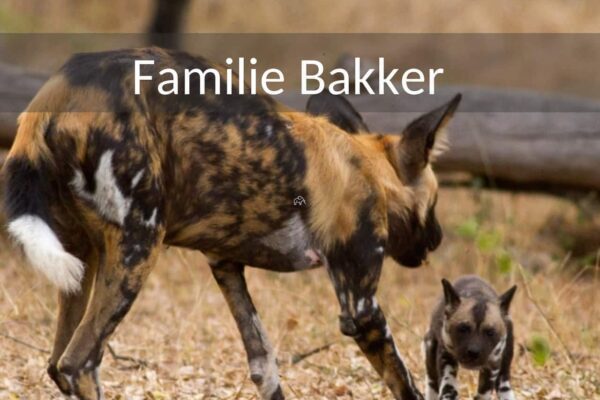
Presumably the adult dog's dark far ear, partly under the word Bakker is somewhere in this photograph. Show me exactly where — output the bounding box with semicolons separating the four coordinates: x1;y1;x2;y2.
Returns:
306;92;369;133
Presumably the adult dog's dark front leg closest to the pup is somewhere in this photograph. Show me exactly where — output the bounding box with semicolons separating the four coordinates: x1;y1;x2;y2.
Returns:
327;239;423;400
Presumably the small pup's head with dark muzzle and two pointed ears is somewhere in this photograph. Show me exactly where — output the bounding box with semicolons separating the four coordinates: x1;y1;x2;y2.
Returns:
442;281;516;369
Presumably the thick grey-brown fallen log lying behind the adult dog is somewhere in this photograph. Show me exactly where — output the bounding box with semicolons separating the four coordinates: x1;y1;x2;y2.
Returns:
0;64;600;190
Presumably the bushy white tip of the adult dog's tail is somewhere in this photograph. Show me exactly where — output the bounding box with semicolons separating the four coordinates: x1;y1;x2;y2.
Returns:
8;215;84;293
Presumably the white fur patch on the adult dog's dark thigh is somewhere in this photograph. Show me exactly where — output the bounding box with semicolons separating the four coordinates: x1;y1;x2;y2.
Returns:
71;150;132;225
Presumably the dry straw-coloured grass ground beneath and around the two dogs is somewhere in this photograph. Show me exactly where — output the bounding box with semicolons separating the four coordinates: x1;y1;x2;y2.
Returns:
0;189;600;400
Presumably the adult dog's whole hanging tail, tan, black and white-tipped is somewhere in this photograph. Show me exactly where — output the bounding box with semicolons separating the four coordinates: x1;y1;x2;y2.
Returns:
3;113;84;292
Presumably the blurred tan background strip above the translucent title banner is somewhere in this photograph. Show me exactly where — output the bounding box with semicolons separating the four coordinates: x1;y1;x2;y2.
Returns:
0;0;600;33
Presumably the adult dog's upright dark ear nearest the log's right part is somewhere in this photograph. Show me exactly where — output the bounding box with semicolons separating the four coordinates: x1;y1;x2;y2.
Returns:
402;93;462;176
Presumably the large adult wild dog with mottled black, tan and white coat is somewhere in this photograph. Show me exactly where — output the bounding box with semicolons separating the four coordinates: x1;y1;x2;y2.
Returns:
4;48;460;399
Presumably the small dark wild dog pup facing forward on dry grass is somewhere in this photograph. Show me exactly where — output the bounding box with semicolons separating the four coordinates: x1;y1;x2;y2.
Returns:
424;275;517;400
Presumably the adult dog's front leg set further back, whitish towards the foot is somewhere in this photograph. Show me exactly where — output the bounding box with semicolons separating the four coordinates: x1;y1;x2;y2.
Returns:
211;261;284;400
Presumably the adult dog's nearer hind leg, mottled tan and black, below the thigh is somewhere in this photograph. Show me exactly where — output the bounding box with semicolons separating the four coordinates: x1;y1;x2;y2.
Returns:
58;227;164;400
